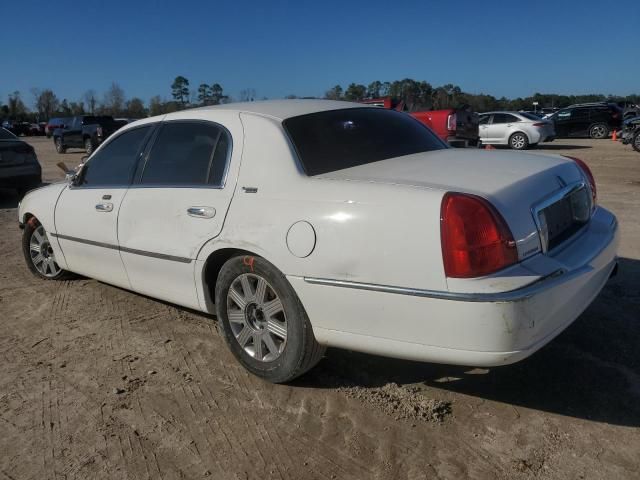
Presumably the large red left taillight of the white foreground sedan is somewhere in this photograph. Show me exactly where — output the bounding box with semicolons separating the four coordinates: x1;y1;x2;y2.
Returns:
440;193;518;278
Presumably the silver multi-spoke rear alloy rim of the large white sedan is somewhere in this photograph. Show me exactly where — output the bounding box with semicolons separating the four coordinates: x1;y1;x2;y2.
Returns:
227;273;287;362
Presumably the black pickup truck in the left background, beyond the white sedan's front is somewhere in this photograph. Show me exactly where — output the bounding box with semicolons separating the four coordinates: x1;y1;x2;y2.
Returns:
53;115;122;155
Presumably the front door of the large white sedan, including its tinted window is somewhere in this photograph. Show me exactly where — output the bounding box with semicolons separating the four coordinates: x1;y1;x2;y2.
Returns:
55;126;152;288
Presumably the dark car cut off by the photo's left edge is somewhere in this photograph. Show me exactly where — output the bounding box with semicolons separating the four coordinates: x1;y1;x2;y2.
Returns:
0;128;42;197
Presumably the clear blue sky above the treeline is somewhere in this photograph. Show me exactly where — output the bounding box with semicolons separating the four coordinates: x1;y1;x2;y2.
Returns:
0;0;640;104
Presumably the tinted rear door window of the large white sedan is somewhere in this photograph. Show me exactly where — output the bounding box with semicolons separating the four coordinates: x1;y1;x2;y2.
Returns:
140;122;230;186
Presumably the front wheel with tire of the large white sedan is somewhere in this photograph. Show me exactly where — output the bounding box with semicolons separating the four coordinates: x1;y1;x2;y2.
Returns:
22;217;72;280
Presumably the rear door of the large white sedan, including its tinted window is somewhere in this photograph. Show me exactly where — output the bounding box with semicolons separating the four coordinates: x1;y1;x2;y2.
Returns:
118;116;242;308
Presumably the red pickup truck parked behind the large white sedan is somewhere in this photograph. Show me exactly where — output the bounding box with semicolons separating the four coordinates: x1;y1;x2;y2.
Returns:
361;97;480;147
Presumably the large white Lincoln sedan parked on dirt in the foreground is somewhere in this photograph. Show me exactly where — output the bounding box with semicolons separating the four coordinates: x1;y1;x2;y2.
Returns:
19;100;619;382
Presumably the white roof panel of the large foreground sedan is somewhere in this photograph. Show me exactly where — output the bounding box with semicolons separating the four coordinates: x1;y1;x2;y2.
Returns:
166;99;364;120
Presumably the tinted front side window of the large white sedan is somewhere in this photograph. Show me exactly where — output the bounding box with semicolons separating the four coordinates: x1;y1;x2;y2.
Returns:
78;125;152;187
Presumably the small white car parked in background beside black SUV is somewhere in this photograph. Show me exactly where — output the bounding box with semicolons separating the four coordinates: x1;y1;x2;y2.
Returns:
479;112;556;150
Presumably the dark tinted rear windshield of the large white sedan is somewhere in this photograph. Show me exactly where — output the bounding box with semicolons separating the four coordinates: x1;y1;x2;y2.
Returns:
283;107;448;176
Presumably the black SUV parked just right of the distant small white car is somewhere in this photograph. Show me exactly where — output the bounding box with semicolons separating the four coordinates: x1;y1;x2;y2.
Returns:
547;103;622;138
